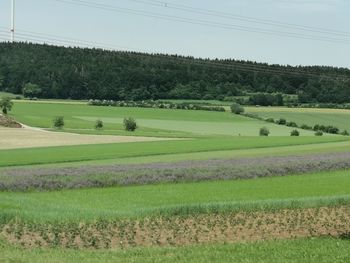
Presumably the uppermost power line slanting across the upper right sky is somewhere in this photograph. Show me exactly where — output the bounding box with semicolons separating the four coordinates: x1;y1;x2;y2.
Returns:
128;0;350;37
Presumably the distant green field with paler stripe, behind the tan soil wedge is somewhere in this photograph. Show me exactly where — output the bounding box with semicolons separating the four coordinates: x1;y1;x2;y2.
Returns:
11;101;313;136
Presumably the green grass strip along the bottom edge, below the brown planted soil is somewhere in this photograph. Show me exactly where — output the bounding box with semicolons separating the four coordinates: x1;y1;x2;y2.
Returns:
0;238;350;263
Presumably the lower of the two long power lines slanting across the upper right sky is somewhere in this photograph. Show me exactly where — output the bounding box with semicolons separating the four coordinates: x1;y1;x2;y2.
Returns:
54;0;350;44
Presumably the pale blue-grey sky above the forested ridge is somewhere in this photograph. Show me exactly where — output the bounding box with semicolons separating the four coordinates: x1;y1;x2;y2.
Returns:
0;0;350;68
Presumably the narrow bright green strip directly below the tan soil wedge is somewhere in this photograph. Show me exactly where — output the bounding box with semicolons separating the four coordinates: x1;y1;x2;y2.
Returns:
0;136;349;167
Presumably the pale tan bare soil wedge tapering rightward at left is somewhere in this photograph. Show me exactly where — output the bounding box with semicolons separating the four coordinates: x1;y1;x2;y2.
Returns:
0;127;171;150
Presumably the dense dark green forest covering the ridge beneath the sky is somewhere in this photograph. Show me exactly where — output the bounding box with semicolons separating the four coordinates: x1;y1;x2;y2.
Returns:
0;43;350;103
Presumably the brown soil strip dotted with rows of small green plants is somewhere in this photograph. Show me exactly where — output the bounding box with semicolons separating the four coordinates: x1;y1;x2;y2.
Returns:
0;206;350;249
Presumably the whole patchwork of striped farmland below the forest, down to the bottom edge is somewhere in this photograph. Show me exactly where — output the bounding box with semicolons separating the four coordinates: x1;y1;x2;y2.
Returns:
0;100;350;262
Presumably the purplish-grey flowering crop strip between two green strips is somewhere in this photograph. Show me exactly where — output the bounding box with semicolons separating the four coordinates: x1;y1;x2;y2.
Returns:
0;152;350;191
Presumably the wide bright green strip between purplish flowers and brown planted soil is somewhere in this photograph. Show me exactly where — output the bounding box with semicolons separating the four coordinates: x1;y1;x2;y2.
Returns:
0;170;350;222
